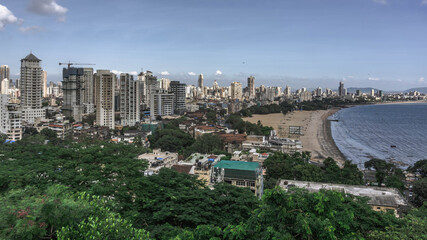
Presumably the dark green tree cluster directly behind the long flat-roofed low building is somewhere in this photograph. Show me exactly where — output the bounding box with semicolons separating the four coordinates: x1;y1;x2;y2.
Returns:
264;152;363;187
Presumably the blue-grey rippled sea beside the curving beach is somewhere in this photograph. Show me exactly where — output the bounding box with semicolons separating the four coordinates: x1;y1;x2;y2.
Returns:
329;103;427;169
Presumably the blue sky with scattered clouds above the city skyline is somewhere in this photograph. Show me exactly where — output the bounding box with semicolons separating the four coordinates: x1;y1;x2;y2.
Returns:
0;0;427;91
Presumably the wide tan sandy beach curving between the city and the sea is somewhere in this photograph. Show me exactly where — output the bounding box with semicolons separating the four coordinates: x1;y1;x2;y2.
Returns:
244;108;345;165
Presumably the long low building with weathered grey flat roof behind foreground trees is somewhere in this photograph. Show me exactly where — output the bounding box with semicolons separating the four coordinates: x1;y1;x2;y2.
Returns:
278;180;408;216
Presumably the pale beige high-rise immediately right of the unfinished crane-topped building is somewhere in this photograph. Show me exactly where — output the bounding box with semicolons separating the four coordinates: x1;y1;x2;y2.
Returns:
94;70;116;129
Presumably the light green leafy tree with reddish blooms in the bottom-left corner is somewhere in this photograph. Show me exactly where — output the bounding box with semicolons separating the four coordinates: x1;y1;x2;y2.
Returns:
0;185;115;239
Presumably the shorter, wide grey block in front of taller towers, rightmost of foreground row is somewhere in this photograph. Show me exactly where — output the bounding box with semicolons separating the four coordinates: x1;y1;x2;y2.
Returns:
150;90;175;120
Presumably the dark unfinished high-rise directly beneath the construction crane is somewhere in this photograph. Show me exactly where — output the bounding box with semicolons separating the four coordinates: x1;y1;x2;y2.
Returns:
62;67;84;122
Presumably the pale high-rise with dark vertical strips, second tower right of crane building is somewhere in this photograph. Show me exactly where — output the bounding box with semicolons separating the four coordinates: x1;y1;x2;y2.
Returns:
120;73;141;126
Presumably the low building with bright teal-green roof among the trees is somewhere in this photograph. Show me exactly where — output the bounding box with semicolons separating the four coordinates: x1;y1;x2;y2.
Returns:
211;160;264;198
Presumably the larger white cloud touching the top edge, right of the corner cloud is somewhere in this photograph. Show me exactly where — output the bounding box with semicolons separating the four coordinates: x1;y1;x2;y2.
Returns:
28;0;68;22
